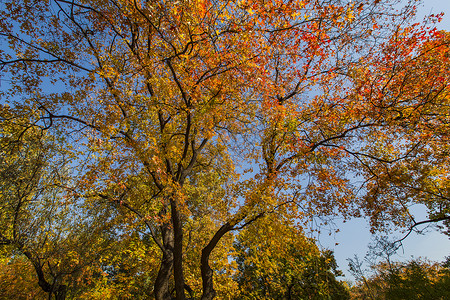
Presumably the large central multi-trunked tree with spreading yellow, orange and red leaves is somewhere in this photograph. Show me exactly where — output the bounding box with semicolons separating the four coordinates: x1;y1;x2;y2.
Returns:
0;0;448;300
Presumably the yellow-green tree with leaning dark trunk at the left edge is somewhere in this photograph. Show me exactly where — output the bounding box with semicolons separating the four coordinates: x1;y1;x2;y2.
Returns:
0;106;71;299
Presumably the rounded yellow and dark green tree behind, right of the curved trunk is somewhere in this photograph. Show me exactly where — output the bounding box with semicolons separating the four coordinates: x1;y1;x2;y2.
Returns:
234;217;350;299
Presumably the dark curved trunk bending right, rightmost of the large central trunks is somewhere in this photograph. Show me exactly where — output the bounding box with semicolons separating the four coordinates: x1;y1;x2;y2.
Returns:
200;223;233;300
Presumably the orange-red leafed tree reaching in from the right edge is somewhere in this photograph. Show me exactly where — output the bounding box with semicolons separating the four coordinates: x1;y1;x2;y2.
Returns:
346;26;450;237
